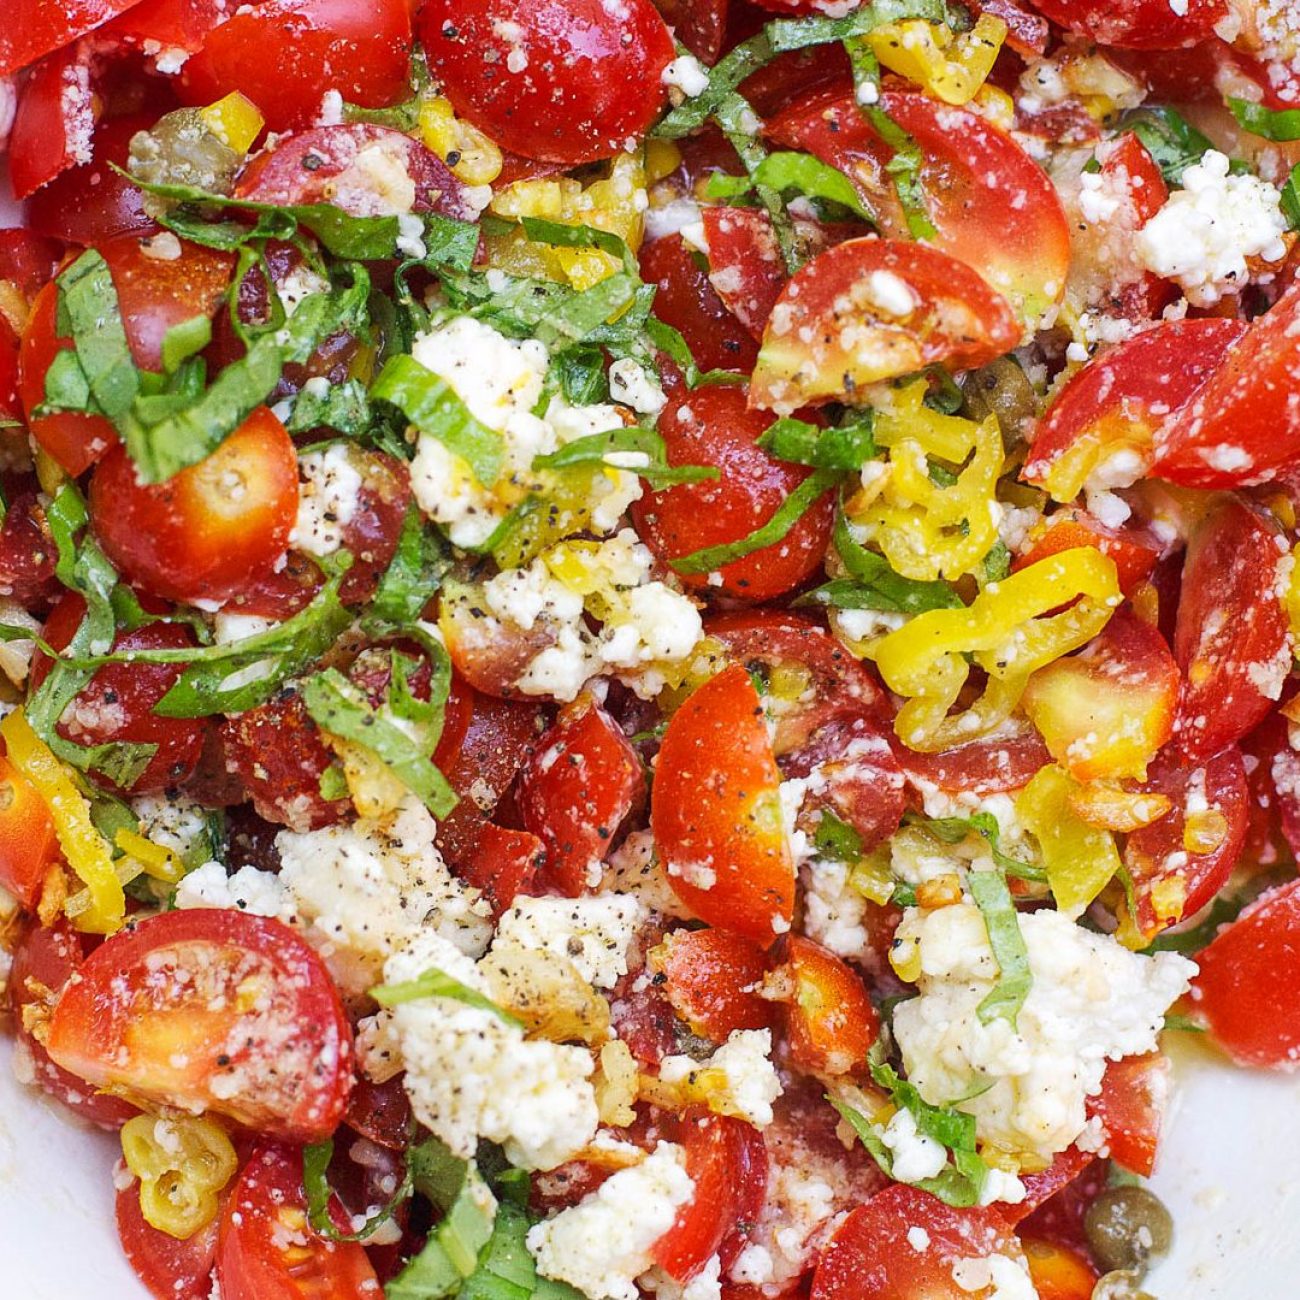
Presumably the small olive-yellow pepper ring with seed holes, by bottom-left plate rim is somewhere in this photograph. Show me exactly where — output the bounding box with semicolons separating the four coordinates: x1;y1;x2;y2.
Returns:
121;1115;239;1240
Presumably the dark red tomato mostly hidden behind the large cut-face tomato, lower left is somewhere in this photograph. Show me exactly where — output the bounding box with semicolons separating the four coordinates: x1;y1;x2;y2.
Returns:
5;920;138;1128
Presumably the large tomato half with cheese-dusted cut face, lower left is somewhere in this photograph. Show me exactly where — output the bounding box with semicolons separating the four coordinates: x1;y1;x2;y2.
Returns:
46;909;352;1141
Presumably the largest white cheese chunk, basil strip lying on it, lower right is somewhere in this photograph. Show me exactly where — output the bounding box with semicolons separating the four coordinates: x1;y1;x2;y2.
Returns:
894;904;1196;1158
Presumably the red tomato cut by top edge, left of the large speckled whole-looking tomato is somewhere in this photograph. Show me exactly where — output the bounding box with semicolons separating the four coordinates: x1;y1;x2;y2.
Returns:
181;0;411;131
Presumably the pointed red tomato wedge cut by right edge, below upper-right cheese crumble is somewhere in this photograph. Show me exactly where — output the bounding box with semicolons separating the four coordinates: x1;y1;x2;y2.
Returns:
1152;283;1300;488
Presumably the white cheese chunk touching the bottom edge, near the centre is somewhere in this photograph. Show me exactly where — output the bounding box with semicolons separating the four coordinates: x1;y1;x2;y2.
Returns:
528;1141;696;1300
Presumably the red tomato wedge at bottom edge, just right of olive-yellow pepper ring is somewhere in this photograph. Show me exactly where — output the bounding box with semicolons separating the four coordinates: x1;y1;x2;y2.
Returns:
216;1147;382;1300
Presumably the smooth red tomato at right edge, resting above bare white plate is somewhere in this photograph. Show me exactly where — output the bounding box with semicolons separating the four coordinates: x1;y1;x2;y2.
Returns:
1192;880;1300;1070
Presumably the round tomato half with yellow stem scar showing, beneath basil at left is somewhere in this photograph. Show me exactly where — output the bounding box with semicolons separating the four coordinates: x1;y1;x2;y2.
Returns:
90;407;298;601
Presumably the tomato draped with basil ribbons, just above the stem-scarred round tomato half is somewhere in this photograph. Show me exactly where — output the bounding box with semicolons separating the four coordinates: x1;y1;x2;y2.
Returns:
18;235;234;475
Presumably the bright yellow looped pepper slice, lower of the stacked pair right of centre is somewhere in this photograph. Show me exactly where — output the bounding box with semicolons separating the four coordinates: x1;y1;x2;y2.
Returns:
872;546;1122;753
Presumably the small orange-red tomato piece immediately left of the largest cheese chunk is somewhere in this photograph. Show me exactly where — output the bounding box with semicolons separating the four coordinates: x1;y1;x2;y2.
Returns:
767;935;880;1075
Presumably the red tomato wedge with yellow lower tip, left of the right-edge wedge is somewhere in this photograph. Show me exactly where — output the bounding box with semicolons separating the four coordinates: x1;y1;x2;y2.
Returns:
1021;317;1247;502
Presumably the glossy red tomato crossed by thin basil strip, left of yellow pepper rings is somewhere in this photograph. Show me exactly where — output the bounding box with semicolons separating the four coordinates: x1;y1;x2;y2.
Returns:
632;385;835;603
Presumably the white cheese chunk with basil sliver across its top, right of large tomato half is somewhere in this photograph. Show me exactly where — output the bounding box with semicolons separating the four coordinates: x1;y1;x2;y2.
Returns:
371;931;598;1175
